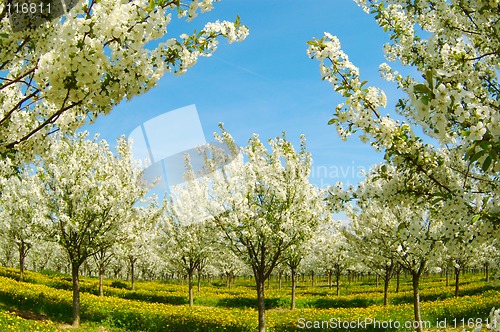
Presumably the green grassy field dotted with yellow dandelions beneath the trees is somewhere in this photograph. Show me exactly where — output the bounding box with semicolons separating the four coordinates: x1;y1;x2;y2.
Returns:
0;268;500;331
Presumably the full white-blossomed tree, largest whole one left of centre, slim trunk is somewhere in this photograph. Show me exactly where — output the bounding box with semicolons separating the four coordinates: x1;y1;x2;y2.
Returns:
36;133;147;326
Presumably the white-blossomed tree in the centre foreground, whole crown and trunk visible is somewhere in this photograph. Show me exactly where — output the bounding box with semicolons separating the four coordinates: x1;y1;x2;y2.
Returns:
202;130;323;331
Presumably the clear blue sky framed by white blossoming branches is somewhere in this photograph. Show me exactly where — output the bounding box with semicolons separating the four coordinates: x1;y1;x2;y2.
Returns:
86;0;400;191
